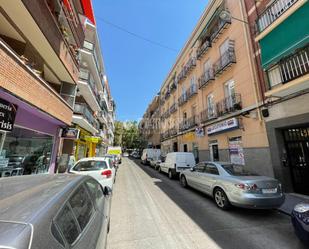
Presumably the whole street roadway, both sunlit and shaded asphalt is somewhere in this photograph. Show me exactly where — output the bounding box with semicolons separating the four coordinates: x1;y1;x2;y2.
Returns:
107;158;305;249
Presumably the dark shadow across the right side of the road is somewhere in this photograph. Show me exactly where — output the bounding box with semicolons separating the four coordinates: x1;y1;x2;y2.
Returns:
129;160;305;249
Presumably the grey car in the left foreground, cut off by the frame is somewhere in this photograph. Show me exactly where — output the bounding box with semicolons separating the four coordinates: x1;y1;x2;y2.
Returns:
0;174;112;249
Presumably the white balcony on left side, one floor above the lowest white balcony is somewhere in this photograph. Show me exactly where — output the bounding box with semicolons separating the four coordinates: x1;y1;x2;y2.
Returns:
78;68;101;111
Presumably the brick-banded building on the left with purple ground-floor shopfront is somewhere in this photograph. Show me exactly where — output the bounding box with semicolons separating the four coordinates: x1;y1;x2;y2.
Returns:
0;0;84;177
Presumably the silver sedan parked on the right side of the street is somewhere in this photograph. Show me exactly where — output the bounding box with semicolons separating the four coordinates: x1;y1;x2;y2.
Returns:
180;162;285;209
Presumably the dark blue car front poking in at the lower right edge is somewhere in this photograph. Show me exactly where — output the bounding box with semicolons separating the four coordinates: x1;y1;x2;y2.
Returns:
291;203;309;247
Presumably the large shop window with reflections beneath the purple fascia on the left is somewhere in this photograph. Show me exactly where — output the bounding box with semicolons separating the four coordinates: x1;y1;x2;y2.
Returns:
0;127;53;177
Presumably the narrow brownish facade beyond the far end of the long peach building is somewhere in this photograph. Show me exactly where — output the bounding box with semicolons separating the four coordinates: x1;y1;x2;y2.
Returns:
139;96;161;149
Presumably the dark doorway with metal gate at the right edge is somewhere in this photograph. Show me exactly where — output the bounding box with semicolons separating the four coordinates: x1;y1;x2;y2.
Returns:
282;127;309;195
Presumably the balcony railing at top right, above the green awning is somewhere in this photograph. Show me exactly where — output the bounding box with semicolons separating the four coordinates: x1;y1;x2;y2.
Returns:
257;0;299;33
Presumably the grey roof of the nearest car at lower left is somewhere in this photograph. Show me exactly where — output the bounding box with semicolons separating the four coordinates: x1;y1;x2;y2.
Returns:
0;174;85;224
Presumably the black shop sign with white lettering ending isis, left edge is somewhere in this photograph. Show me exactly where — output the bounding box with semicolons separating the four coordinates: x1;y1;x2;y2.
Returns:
0;99;18;131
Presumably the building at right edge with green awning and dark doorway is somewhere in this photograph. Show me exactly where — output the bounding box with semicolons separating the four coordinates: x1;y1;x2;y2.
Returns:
245;0;309;195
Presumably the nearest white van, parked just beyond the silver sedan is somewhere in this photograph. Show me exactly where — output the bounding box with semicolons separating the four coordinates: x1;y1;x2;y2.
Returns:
159;152;196;179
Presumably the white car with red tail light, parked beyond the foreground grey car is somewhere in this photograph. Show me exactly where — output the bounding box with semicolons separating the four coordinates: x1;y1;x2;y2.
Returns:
69;157;116;189
